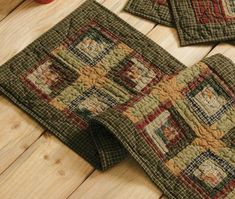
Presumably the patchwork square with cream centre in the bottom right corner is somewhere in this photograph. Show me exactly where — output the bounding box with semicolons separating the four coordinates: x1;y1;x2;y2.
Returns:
181;150;235;198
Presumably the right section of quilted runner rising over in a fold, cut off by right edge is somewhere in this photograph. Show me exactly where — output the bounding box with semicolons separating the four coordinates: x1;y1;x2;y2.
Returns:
91;55;235;199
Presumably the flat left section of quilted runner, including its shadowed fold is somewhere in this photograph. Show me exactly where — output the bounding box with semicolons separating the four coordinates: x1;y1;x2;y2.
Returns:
0;0;185;169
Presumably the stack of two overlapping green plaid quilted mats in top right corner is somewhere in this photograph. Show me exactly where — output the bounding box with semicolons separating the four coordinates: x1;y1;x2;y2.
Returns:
126;0;235;46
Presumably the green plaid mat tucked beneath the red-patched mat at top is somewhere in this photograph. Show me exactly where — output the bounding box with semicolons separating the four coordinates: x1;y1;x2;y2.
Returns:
125;0;174;26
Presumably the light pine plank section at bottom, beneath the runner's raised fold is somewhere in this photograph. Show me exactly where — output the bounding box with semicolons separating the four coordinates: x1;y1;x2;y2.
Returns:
69;158;162;199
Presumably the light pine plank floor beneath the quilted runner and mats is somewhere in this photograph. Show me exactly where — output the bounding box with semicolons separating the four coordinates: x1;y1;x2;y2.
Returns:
0;0;235;199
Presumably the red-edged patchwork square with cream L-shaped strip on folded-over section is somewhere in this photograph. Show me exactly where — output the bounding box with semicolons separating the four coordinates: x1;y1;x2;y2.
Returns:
136;102;196;161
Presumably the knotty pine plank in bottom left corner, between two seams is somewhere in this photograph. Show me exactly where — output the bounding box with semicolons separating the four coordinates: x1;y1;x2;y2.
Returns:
0;135;93;199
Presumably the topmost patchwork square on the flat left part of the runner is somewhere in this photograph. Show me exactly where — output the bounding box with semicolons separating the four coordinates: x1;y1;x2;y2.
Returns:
69;24;116;66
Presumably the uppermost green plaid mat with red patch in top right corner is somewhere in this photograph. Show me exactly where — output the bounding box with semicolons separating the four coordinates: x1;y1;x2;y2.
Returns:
169;0;235;45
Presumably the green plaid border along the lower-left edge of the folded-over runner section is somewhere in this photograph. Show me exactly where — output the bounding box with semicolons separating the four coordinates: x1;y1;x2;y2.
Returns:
91;109;183;198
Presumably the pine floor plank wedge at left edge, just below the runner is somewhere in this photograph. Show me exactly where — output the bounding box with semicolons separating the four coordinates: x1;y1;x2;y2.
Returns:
0;97;43;173
